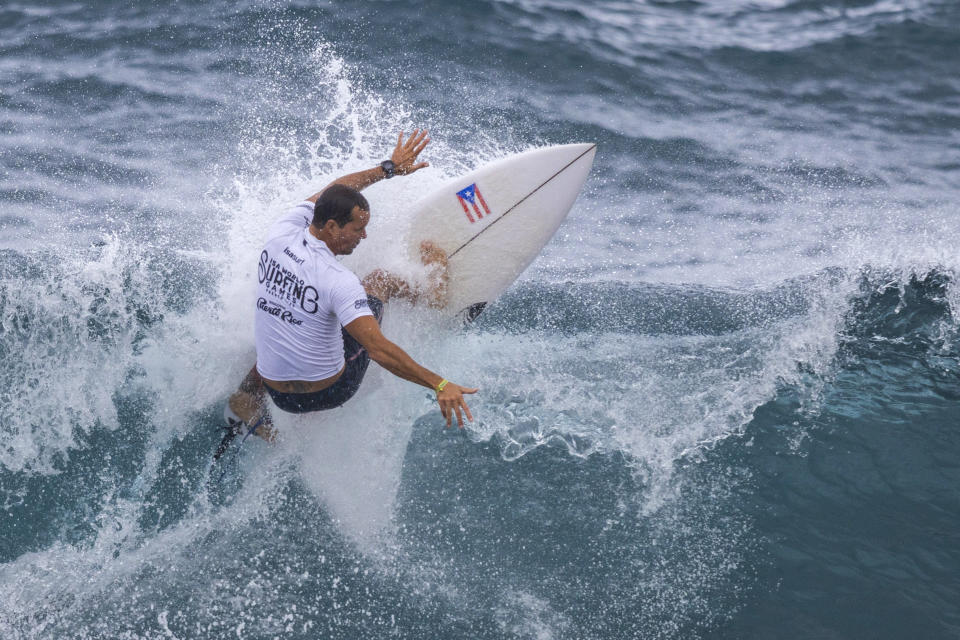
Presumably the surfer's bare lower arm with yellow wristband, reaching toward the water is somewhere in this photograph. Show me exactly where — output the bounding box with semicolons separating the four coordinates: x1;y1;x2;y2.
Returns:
344;316;477;429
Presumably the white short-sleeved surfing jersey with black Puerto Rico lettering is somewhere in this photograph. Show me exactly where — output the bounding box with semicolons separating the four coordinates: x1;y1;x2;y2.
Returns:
254;202;373;381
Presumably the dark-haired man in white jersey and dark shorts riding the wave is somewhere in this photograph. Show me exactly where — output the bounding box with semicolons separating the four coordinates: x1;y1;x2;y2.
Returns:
216;130;477;458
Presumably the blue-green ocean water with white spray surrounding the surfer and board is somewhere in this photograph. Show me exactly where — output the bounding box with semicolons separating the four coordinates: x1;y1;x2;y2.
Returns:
0;0;960;640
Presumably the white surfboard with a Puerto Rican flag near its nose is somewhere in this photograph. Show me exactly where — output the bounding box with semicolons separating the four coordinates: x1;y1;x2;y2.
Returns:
409;144;596;320
